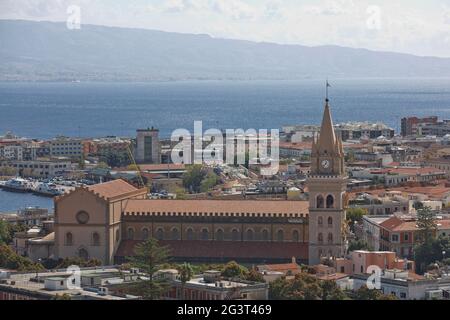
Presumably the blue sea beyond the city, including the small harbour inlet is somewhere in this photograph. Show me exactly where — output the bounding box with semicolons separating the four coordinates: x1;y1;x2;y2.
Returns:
0;79;450;212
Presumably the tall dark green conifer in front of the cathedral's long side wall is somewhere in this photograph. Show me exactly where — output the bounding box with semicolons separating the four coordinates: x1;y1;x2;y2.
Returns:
128;238;169;300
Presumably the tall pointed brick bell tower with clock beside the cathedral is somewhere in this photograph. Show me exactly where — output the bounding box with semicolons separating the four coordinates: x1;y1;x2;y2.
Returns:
307;95;347;265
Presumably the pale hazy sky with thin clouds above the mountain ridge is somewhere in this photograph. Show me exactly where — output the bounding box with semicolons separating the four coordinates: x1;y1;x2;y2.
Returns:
0;0;450;57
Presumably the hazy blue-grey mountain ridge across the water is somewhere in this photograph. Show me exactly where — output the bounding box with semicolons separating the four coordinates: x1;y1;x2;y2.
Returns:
0;20;450;81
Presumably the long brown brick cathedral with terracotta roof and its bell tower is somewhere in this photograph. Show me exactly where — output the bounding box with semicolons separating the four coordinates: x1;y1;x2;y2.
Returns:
52;99;347;265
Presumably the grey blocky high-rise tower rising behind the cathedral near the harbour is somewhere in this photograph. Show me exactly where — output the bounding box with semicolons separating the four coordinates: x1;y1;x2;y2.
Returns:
136;127;161;163
